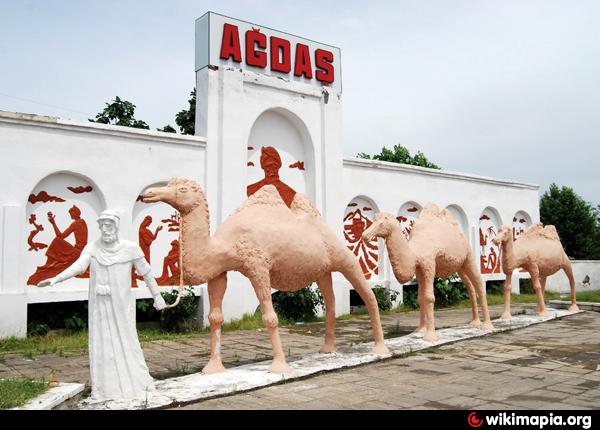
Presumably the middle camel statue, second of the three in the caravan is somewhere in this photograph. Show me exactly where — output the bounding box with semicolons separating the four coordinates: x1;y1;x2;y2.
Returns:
363;203;494;342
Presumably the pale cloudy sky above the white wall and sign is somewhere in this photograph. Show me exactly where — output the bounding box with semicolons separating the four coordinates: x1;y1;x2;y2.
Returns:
0;0;600;204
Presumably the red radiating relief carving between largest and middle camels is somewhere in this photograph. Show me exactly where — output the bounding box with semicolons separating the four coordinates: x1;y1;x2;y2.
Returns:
344;204;379;279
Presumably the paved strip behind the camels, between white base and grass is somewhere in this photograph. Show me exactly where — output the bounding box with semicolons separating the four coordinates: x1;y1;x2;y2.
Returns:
0;305;533;385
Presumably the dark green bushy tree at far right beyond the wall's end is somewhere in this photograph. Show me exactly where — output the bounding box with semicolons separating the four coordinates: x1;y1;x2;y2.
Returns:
540;184;600;260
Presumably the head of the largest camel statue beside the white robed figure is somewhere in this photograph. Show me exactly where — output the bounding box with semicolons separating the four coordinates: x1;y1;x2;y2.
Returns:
142;178;204;214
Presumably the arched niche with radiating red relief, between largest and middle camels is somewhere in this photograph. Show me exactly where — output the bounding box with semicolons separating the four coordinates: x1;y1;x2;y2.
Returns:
343;196;379;279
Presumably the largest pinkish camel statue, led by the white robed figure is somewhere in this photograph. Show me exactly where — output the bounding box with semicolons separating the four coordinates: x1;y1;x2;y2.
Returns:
143;178;389;373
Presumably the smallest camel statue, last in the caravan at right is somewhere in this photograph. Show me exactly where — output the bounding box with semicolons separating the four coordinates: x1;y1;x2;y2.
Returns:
493;223;579;319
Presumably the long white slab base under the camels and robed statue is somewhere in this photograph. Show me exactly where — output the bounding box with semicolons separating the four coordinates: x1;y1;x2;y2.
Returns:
71;308;581;409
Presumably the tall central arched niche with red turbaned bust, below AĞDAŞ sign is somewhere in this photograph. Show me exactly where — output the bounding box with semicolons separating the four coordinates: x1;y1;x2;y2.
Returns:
246;108;315;207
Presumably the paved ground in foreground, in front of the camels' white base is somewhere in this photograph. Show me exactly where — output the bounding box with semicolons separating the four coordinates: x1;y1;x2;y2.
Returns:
180;312;600;410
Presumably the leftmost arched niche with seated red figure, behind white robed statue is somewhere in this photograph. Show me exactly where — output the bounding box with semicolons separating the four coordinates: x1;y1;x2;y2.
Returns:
25;172;106;285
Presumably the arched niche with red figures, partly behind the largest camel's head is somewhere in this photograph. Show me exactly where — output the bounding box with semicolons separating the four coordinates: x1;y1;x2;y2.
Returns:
132;181;181;287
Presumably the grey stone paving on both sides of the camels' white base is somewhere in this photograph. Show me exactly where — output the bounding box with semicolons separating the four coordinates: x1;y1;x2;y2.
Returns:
0;305;600;409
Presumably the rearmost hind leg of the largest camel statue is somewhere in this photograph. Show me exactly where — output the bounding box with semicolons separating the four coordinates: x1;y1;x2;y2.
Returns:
340;262;390;355
